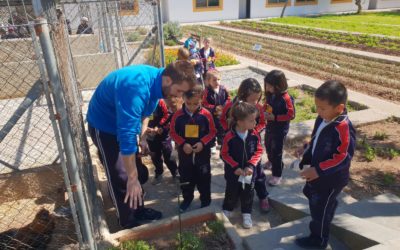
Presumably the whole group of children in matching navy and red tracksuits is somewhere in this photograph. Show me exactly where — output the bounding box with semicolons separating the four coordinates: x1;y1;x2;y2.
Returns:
148;38;355;248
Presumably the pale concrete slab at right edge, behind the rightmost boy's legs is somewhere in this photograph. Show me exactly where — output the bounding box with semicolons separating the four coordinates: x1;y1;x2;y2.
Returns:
337;193;400;231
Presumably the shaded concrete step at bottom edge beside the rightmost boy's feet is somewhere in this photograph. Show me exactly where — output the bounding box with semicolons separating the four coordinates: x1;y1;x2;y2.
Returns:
243;217;348;250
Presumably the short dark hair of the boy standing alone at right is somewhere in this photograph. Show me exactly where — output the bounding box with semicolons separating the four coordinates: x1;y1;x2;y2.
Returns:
315;80;347;107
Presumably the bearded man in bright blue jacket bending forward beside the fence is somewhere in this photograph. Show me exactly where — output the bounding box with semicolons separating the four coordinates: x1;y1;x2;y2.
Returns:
87;61;196;228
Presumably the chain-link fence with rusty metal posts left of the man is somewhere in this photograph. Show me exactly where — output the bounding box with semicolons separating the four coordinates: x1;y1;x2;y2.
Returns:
0;0;160;249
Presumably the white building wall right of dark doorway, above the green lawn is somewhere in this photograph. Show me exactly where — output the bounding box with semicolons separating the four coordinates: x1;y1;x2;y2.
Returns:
251;0;370;18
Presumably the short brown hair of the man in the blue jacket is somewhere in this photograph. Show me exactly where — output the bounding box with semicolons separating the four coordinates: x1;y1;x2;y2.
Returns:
163;61;197;88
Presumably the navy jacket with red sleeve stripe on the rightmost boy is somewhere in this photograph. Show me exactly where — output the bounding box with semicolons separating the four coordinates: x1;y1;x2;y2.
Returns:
300;111;356;187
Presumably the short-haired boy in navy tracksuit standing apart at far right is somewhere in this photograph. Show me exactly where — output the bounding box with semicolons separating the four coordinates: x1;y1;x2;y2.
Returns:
296;80;356;249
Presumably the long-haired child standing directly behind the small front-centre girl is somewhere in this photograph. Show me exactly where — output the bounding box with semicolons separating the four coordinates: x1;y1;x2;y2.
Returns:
220;78;269;212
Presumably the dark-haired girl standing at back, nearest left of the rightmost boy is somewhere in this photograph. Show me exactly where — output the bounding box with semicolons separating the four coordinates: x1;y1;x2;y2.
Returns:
264;70;295;186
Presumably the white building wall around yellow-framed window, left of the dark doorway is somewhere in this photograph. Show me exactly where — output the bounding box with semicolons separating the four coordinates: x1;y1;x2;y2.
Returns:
164;0;239;23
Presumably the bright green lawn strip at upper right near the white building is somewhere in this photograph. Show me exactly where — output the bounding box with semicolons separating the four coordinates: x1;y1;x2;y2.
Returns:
265;12;400;37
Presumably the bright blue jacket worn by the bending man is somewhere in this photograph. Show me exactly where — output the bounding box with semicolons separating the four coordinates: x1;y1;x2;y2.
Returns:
87;65;164;155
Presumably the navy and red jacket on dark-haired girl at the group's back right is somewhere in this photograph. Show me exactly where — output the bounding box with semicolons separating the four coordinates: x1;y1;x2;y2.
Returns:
264;91;295;133
